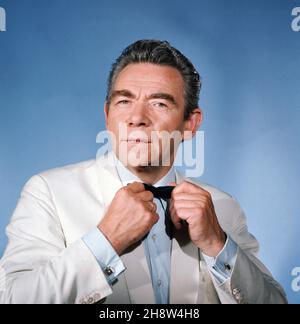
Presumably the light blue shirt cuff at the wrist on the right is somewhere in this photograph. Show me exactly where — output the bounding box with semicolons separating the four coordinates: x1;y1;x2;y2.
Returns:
202;235;238;285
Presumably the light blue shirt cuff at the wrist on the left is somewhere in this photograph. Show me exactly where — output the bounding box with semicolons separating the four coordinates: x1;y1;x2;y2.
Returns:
82;227;125;285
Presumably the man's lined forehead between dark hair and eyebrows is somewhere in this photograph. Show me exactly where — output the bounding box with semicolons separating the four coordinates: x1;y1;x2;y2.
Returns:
113;63;184;97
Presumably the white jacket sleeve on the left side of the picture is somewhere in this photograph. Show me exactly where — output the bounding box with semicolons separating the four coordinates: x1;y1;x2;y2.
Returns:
0;176;112;304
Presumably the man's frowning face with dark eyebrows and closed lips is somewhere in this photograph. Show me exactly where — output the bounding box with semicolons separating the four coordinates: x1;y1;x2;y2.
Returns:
105;63;201;167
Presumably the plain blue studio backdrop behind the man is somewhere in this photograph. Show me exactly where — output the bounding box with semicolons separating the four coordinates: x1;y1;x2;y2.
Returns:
0;0;300;303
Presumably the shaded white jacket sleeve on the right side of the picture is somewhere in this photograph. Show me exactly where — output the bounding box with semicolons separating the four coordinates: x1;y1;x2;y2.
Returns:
212;198;287;304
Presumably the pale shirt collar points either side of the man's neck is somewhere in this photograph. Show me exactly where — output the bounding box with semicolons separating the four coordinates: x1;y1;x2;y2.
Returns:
113;153;175;187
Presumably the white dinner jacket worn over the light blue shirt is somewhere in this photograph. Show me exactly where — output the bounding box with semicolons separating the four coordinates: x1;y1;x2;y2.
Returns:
0;154;286;304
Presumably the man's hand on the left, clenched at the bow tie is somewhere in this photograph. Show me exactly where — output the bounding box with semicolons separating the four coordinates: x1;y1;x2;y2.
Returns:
98;182;159;255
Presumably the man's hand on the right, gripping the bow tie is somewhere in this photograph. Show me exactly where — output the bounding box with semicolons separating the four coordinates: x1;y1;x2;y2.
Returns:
170;181;226;257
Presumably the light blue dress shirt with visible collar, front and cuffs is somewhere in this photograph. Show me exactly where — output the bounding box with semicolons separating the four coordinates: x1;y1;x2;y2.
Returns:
83;157;237;304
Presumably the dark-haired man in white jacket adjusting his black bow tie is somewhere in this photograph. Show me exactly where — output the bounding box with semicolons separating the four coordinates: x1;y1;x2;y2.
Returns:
0;40;286;304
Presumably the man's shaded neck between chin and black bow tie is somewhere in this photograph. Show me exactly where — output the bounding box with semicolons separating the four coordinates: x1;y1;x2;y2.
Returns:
127;165;172;185
